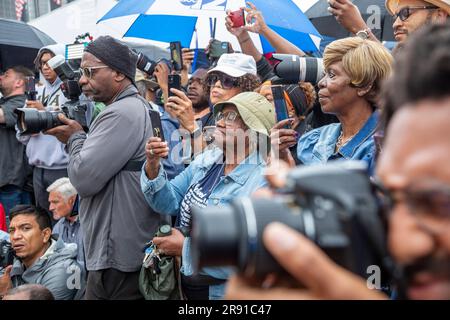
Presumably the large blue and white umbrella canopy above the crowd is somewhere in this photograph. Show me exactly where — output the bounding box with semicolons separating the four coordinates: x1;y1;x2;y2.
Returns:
98;0;321;52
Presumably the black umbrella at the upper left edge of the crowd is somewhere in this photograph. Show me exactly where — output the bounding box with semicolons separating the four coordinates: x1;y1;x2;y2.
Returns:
0;19;55;70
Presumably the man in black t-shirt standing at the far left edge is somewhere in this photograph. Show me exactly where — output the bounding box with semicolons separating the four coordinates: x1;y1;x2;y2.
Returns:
0;66;33;221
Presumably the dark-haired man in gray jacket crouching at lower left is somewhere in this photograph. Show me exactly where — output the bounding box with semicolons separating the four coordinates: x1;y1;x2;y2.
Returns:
0;205;85;300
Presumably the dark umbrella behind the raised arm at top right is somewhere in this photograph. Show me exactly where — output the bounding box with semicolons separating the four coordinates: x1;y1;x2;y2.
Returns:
306;0;395;41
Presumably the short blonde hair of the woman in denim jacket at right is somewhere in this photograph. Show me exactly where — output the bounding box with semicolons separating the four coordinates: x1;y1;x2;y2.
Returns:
323;37;393;104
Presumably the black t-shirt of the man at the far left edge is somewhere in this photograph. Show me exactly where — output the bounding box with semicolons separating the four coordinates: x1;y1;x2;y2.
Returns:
0;95;30;188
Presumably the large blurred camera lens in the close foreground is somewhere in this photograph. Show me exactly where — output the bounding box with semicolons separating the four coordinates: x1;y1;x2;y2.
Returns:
192;198;304;276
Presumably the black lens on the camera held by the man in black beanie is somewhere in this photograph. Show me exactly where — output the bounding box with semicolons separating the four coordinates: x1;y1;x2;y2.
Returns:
15;108;62;134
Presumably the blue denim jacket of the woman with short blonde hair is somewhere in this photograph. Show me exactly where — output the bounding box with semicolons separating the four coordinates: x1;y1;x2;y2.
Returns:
297;111;379;174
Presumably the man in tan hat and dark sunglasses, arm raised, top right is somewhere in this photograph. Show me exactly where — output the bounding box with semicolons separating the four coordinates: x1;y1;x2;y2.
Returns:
328;0;450;42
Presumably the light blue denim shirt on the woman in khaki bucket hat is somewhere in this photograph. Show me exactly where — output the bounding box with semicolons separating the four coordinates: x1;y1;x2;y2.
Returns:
141;148;267;299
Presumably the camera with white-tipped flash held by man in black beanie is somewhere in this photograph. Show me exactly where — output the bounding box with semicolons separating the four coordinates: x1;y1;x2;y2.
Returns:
14;55;88;135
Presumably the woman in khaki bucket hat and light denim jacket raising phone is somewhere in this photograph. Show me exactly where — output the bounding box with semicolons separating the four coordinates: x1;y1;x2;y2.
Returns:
141;92;275;299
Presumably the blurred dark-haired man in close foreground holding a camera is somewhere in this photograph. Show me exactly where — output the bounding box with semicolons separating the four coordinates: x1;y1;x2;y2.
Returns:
228;23;450;300
